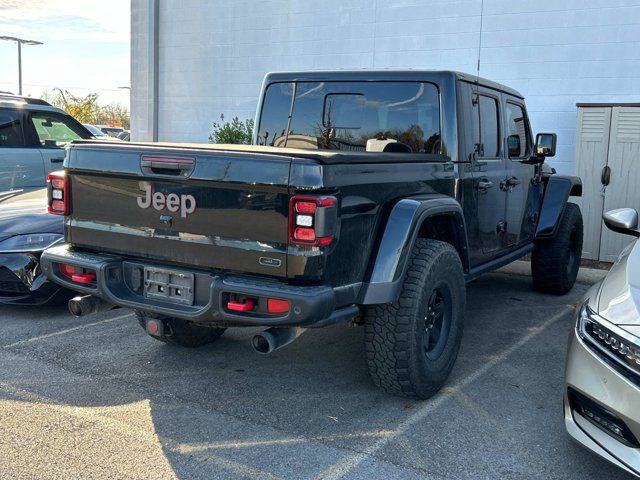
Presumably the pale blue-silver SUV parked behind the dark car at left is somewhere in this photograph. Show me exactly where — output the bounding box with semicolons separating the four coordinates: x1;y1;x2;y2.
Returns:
0;93;93;192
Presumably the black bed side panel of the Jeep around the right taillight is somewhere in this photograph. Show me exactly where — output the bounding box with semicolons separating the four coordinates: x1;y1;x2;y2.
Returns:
287;158;458;286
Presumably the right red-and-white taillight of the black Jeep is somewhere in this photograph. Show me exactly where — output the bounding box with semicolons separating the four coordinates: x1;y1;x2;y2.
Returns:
289;195;337;247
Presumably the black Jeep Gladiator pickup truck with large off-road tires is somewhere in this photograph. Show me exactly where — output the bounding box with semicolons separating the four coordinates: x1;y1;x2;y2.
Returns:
42;71;582;398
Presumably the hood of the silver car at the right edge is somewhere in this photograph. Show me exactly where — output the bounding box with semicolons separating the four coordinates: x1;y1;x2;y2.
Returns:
598;241;640;333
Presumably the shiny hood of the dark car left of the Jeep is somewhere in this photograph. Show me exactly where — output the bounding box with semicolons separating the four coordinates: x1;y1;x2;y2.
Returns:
0;188;63;241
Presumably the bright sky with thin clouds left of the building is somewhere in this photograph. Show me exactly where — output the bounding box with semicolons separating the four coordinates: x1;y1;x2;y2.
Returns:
0;0;131;107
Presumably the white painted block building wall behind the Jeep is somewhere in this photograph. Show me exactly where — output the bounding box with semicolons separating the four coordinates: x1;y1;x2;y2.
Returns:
132;0;640;173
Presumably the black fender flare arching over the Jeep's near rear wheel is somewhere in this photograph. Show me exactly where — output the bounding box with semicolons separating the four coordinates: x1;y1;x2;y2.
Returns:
358;194;469;305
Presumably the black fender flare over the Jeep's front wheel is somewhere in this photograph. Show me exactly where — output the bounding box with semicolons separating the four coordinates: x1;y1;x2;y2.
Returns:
534;175;582;239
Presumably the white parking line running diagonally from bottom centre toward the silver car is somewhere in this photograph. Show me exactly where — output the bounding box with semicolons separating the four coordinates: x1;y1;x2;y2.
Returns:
316;306;575;480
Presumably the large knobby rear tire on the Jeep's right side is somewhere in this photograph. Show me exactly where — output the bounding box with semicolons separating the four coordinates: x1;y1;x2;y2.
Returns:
364;238;465;399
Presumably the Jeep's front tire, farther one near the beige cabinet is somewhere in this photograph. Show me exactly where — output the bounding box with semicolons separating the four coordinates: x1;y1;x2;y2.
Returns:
531;203;583;295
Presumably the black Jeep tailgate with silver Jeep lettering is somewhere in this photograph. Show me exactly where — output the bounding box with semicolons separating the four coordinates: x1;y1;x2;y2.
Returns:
66;145;291;277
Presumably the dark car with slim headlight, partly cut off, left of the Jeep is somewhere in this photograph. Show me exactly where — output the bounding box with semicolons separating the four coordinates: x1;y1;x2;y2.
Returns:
0;188;72;305
